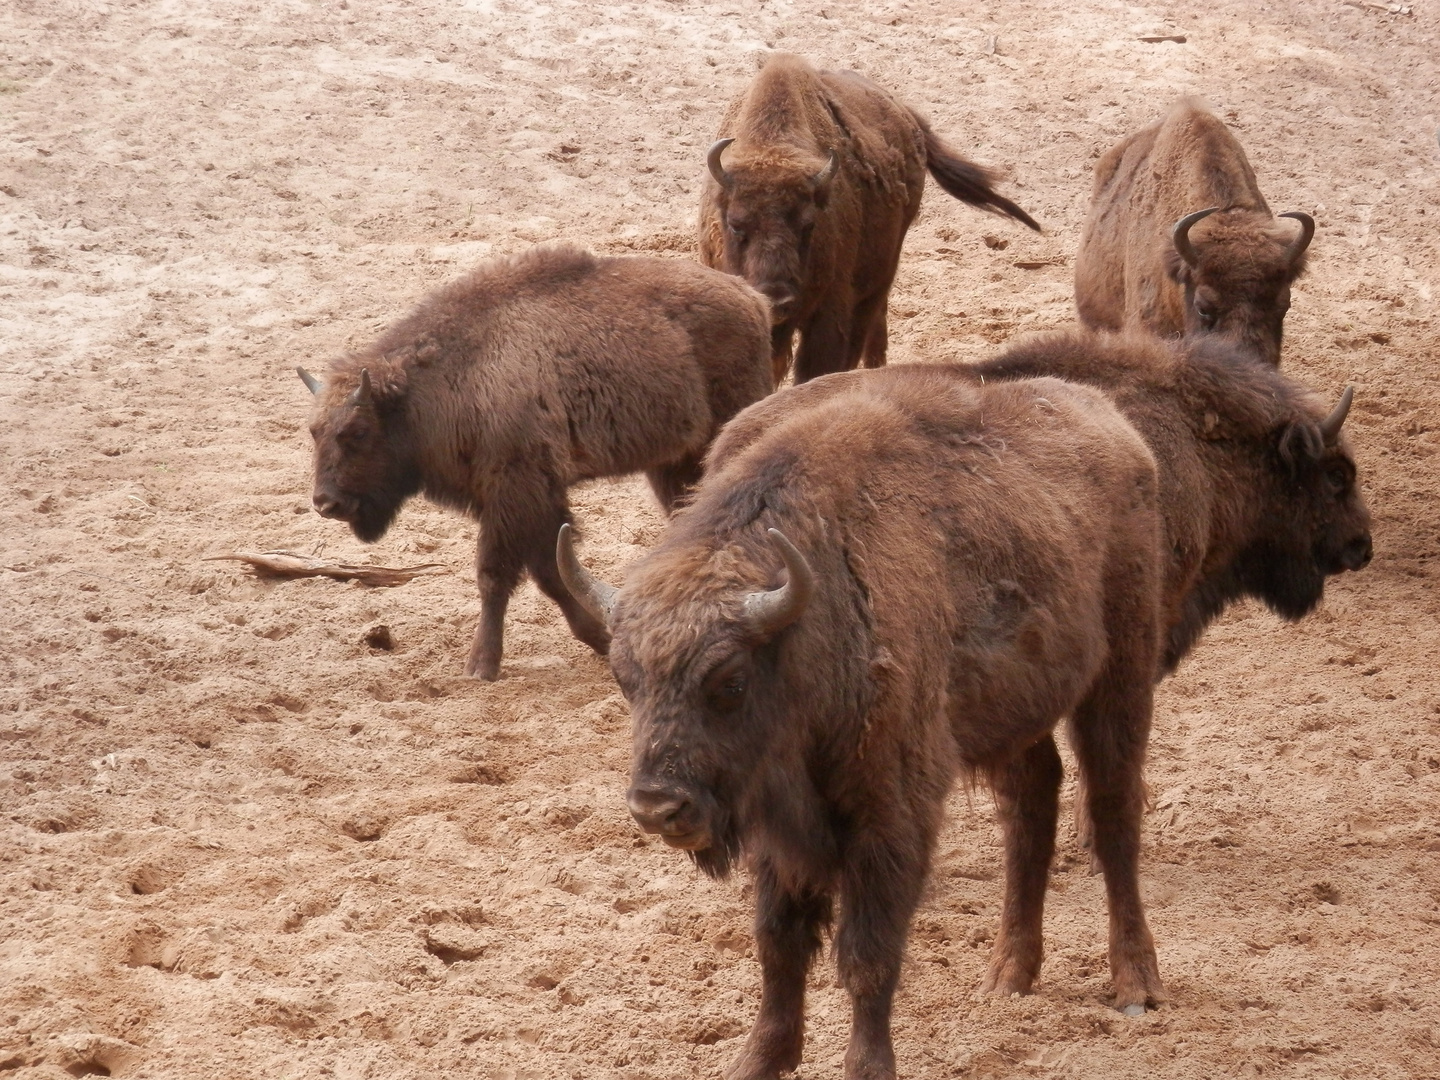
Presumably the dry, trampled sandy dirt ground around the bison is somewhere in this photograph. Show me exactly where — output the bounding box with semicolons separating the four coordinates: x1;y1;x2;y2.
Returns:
0;0;1440;1080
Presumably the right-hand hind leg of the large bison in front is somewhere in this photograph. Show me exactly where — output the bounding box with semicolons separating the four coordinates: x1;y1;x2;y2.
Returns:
1074;679;1165;1017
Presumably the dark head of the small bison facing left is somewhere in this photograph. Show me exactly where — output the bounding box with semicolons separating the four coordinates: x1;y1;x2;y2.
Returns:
295;367;420;543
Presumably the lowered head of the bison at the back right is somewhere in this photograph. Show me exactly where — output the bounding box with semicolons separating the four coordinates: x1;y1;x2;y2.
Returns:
1165;206;1315;366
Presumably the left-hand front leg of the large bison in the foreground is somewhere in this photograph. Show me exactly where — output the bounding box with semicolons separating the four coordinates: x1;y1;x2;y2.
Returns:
726;860;831;1080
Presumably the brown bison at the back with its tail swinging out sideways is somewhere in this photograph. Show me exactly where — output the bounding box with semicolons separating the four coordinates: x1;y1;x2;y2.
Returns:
700;53;1040;383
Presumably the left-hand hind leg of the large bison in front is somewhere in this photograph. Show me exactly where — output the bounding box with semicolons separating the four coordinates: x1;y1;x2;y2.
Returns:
981;736;1063;995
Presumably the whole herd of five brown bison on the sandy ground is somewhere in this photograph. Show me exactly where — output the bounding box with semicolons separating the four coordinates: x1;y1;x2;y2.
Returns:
301;55;1371;1080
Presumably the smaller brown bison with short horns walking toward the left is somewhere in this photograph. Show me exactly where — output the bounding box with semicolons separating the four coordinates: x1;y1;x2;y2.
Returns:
300;246;773;680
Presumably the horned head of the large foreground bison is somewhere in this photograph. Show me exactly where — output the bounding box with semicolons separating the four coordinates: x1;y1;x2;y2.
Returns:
556;526;815;877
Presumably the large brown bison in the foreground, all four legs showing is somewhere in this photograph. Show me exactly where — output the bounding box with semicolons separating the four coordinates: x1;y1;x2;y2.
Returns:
559;364;1162;1080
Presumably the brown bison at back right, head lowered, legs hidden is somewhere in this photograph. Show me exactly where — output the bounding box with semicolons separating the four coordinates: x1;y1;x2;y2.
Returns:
1076;99;1315;364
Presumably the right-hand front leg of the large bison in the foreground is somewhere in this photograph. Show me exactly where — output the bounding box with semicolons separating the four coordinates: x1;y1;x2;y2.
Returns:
835;824;935;1080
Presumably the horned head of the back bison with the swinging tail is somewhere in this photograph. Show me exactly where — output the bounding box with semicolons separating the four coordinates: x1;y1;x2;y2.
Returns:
707;138;840;325
